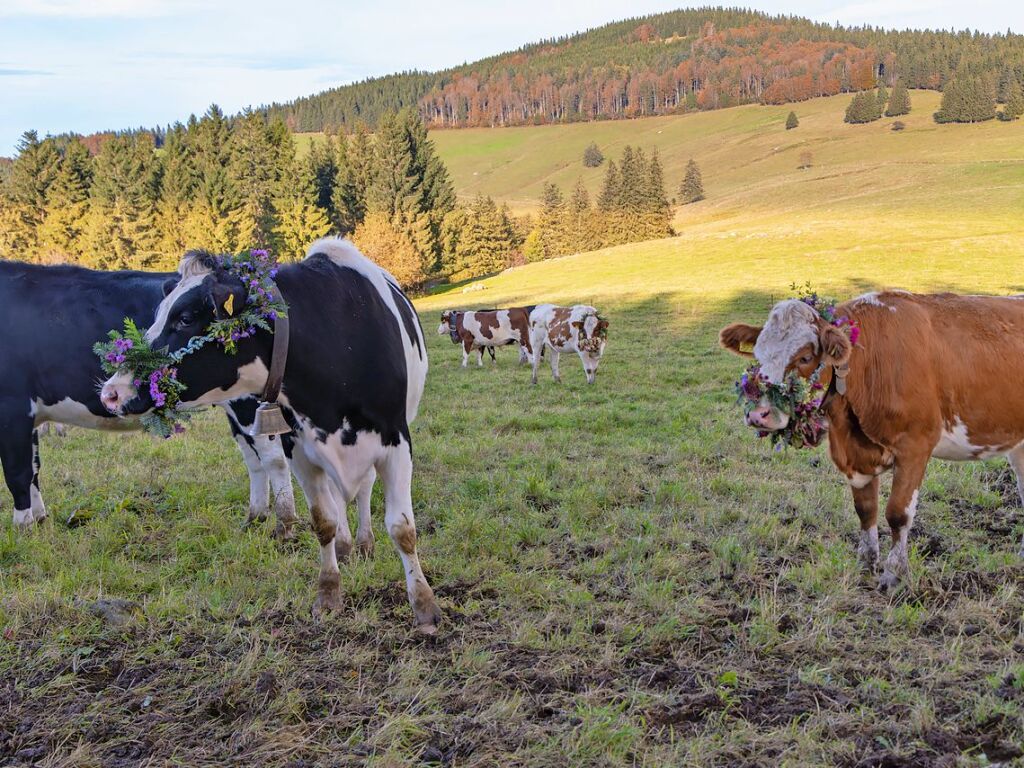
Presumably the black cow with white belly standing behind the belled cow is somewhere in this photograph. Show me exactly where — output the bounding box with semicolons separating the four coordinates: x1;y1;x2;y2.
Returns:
0;261;295;538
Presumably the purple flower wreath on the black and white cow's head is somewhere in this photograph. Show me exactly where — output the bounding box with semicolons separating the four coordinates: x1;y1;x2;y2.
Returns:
93;249;288;437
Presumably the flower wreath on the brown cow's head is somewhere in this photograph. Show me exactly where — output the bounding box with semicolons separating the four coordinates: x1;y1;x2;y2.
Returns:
735;283;860;451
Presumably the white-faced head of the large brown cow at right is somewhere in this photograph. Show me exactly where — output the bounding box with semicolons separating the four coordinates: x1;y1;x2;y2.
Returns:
719;299;853;432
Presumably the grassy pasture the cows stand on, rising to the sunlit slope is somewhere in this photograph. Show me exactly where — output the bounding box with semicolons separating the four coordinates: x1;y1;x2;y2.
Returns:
6;94;1024;768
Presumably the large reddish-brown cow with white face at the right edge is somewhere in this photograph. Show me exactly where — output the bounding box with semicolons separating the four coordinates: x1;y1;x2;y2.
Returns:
720;291;1024;589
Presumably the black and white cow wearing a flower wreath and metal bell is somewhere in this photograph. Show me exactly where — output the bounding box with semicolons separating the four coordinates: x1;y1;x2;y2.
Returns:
102;238;440;634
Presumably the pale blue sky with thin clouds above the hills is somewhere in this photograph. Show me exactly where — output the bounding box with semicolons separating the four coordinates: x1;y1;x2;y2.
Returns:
0;0;1024;156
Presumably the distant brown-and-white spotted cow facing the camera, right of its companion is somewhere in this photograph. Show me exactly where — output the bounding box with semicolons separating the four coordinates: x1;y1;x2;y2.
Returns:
529;304;608;384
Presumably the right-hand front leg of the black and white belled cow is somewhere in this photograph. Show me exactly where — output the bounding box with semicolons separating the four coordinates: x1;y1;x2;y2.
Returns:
377;440;441;635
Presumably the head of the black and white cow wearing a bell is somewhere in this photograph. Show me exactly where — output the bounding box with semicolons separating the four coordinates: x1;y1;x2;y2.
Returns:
100;251;266;415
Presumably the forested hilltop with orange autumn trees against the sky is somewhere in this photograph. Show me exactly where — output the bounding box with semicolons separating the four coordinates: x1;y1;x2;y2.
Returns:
266;8;1024;131
